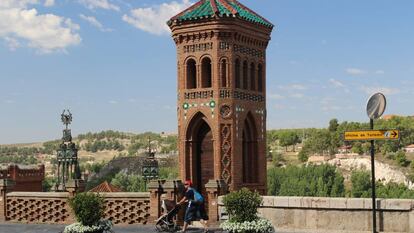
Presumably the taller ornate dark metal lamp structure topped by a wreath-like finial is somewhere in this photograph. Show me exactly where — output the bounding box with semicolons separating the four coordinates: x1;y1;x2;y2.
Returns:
55;110;81;191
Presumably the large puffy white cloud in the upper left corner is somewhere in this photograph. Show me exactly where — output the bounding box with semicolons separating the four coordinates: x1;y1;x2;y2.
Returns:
0;0;81;53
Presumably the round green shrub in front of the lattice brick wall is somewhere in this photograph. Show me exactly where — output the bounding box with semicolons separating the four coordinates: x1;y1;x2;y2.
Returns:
69;193;105;226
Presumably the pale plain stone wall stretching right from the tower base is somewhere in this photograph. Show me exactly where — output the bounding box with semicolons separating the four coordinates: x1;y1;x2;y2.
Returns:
219;196;414;233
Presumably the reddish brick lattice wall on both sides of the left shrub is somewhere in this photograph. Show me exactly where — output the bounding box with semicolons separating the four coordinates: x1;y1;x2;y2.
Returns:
0;192;150;224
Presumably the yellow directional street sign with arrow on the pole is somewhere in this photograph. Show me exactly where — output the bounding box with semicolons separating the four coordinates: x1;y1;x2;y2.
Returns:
345;130;400;141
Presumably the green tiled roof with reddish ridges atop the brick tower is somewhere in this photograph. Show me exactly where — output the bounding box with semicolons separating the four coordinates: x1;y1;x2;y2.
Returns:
168;0;273;28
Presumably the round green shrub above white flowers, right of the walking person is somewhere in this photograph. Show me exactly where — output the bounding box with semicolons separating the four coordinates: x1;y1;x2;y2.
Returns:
223;188;263;222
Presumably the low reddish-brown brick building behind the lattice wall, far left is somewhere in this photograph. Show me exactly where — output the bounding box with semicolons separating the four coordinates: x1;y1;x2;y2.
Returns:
0;164;45;192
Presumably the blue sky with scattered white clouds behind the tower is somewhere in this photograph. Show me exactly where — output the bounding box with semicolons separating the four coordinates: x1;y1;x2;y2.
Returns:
0;0;414;144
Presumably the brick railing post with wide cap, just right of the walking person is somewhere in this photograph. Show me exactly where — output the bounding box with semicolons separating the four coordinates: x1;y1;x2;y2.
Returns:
206;180;227;226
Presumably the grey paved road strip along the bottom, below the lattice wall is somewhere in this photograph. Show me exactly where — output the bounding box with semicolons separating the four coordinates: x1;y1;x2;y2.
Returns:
0;223;293;233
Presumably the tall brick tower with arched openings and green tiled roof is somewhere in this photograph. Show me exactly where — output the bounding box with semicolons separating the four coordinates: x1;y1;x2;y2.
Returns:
168;0;273;194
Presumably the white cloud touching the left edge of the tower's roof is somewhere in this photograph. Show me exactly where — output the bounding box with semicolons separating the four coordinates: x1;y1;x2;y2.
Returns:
122;0;192;35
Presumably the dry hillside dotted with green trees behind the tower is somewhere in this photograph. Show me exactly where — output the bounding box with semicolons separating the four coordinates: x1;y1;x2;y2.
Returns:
0;117;414;194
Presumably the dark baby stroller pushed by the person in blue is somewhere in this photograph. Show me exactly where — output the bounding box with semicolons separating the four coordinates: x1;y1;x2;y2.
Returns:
155;200;180;232
